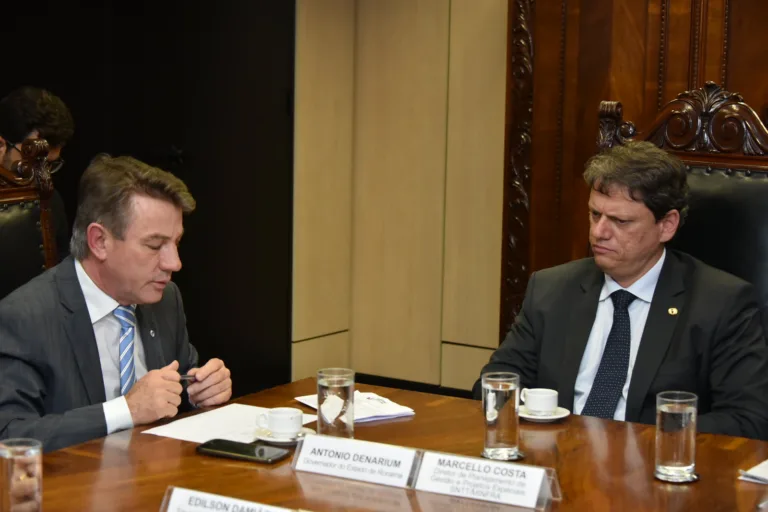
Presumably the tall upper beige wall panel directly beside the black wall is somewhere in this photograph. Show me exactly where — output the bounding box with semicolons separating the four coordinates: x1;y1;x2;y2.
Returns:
293;0;355;340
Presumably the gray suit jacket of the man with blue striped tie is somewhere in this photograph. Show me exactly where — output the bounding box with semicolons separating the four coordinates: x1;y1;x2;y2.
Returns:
0;257;197;451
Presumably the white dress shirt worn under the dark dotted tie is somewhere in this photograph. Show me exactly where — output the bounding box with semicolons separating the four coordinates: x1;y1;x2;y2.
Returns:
573;249;667;421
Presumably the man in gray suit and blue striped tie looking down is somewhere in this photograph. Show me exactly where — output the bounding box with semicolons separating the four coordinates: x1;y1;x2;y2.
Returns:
0;155;232;451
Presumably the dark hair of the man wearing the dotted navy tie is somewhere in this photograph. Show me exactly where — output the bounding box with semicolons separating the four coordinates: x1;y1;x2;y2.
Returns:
584;142;688;225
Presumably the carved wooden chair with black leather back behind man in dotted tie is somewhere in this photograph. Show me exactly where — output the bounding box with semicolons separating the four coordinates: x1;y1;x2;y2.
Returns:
598;82;768;306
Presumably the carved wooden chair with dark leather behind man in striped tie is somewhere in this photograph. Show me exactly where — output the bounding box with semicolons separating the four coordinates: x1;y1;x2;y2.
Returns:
0;139;58;299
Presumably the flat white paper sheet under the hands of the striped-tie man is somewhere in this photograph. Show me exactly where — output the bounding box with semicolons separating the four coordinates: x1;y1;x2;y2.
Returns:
142;404;317;443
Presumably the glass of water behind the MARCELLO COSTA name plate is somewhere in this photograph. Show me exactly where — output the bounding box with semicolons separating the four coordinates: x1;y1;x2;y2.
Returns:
482;372;523;460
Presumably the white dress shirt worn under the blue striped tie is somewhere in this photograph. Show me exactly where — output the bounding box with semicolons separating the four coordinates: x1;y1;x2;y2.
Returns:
75;260;147;434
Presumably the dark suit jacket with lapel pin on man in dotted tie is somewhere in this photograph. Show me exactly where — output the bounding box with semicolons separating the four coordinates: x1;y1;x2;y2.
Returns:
474;249;768;439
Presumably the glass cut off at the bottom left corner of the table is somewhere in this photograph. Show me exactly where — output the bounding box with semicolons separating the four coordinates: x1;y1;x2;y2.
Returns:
0;439;43;512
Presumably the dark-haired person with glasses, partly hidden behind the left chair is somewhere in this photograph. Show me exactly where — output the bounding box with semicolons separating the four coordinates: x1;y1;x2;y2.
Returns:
0;87;75;262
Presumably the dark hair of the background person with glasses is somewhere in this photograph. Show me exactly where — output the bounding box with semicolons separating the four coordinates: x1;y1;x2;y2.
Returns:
0;87;75;147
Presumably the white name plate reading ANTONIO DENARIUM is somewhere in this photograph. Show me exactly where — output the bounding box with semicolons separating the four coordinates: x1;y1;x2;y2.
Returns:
293;435;416;487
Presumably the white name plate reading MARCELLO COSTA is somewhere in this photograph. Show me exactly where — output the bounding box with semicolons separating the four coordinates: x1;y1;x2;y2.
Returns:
415;452;549;508
